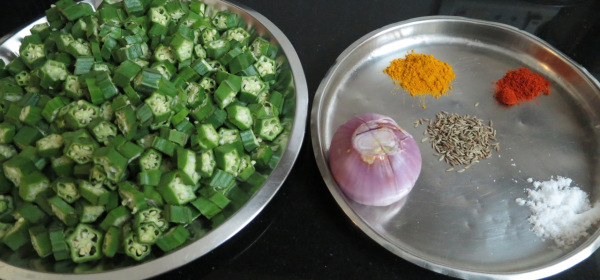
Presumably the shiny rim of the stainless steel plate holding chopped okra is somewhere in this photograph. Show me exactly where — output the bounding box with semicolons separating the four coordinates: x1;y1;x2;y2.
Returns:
0;0;308;280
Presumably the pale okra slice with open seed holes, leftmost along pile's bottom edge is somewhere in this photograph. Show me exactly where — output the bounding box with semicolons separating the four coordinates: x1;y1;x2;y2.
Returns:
67;224;103;263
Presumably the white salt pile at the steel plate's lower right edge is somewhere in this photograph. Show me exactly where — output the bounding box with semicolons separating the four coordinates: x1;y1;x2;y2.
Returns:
516;176;600;248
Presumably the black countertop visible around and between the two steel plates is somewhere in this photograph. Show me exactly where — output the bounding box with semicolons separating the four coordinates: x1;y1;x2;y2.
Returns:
0;0;600;280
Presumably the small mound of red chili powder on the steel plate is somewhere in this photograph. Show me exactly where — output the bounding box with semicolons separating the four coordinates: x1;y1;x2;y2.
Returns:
494;68;550;106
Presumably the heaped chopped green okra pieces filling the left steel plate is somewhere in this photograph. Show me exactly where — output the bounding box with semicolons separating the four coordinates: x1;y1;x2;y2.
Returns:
0;0;295;263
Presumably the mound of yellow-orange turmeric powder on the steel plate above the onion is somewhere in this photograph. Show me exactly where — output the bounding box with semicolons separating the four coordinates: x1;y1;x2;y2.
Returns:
383;52;455;98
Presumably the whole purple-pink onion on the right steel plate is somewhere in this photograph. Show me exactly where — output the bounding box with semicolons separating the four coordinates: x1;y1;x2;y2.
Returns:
329;113;421;206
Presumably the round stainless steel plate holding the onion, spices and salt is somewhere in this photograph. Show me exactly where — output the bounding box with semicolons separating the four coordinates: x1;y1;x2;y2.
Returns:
311;16;600;279
